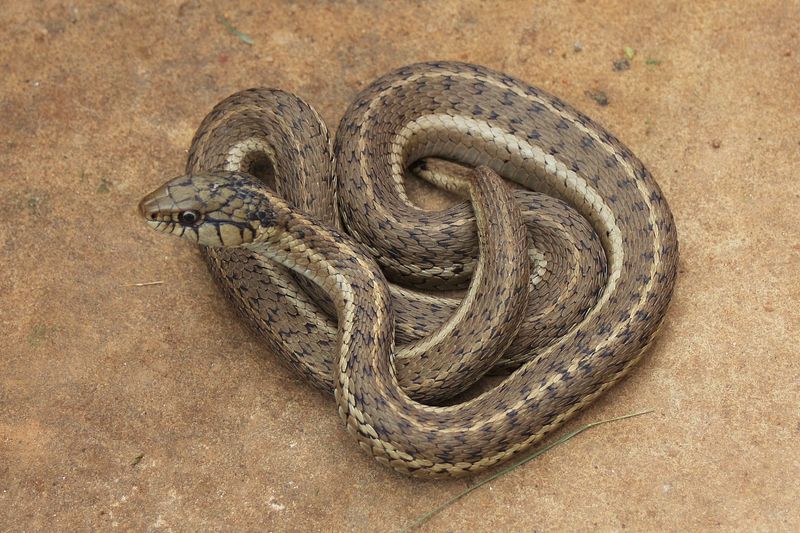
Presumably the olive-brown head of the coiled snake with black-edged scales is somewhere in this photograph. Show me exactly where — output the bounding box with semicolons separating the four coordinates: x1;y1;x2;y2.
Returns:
139;172;275;247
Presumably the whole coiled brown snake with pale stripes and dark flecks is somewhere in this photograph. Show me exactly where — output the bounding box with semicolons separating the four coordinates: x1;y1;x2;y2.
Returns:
139;61;678;477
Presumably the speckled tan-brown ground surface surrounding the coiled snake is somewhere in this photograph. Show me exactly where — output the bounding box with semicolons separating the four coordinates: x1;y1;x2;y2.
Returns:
0;1;800;531
